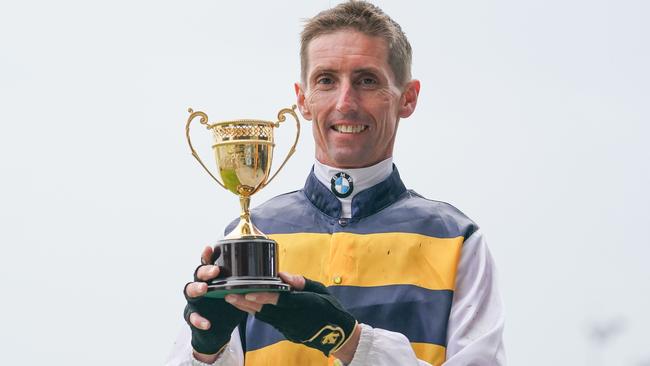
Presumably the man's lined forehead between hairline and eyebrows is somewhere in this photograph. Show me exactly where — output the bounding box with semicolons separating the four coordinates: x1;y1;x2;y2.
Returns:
307;30;392;75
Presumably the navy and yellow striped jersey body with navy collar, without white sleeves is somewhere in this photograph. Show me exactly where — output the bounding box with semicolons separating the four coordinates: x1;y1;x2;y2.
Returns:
226;167;477;366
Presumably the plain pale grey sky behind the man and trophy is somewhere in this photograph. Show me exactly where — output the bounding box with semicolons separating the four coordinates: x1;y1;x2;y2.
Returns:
0;0;650;365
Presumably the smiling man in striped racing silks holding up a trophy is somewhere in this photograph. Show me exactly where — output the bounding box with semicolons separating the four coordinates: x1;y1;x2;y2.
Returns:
168;2;505;366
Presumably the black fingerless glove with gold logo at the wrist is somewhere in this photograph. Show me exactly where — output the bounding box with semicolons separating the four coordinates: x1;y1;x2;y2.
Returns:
255;278;357;356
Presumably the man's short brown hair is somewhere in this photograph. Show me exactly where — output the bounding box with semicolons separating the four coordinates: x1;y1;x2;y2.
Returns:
300;0;412;86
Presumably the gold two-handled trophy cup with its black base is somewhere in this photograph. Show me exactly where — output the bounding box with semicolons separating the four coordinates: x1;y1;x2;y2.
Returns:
185;105;300;298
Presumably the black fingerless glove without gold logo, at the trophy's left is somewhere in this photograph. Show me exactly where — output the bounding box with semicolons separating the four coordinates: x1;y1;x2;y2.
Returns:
183;266;248;354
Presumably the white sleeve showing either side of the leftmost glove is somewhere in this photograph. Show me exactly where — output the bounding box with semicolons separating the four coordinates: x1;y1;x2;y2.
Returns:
165;323;244;366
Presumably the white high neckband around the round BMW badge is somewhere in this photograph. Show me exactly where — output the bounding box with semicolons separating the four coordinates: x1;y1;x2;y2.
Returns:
314;157;393;218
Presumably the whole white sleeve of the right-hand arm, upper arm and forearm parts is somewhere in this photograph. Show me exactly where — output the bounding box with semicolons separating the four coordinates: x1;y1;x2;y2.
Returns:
349;231;505;366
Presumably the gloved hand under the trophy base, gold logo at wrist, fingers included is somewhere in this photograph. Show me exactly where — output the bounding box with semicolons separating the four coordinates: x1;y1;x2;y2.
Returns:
226;273;358;362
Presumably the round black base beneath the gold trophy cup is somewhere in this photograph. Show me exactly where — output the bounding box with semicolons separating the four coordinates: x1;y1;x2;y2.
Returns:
205;238;290;298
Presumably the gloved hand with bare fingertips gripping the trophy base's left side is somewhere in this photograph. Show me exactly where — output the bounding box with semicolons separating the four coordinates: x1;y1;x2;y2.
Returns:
183;247;247;362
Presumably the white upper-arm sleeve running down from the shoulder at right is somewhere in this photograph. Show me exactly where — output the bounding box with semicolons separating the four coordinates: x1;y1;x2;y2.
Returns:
444;230;506;366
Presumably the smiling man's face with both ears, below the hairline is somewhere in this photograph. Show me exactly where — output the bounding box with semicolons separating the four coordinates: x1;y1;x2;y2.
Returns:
296;30;420;168
